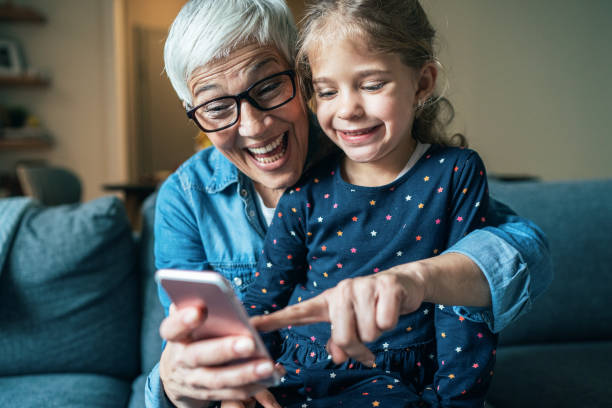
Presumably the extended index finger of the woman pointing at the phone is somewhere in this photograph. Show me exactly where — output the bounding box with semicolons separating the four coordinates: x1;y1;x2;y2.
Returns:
251;294;330;332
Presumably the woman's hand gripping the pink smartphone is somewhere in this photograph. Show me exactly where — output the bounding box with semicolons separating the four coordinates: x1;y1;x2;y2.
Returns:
159;305;282;407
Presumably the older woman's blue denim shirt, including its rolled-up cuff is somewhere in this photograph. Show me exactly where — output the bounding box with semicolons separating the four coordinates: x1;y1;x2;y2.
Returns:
145;148;552;407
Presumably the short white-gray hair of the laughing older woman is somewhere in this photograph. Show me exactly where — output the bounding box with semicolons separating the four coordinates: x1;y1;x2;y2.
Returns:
164;0;297;105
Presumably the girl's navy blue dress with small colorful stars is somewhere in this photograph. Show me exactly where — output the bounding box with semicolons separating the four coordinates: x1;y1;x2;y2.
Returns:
244;145;497;407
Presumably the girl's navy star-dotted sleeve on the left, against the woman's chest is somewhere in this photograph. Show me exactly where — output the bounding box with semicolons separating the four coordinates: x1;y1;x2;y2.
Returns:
243;190;306;316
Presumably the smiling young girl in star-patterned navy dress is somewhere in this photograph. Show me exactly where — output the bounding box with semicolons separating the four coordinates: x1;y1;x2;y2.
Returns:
244;0;497;407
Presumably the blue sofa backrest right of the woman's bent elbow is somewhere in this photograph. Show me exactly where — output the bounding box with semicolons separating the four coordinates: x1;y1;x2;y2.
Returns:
490;180;612;345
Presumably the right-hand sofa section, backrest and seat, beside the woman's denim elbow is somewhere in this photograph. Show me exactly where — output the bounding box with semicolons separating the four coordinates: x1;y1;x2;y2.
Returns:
488;180;612;408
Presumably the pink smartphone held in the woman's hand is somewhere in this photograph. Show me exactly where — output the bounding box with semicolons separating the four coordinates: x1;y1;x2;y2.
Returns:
155;269;280;386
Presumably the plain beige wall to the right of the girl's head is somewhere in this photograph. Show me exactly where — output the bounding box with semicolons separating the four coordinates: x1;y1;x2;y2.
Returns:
423;0;612;180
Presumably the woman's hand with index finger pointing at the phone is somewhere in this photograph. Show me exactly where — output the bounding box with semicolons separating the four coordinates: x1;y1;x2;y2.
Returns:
251;262;426;366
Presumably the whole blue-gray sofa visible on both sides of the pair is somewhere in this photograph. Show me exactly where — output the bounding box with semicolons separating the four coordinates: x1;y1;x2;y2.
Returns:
0;180;612;408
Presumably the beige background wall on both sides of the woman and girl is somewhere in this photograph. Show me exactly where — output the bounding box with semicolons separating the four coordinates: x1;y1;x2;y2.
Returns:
0;0;612;199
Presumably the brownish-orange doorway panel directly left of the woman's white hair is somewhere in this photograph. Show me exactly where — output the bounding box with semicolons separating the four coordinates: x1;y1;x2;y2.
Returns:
119;0;191;180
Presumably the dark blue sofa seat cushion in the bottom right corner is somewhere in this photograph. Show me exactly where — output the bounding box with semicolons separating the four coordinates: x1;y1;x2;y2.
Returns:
487;342;612;408
